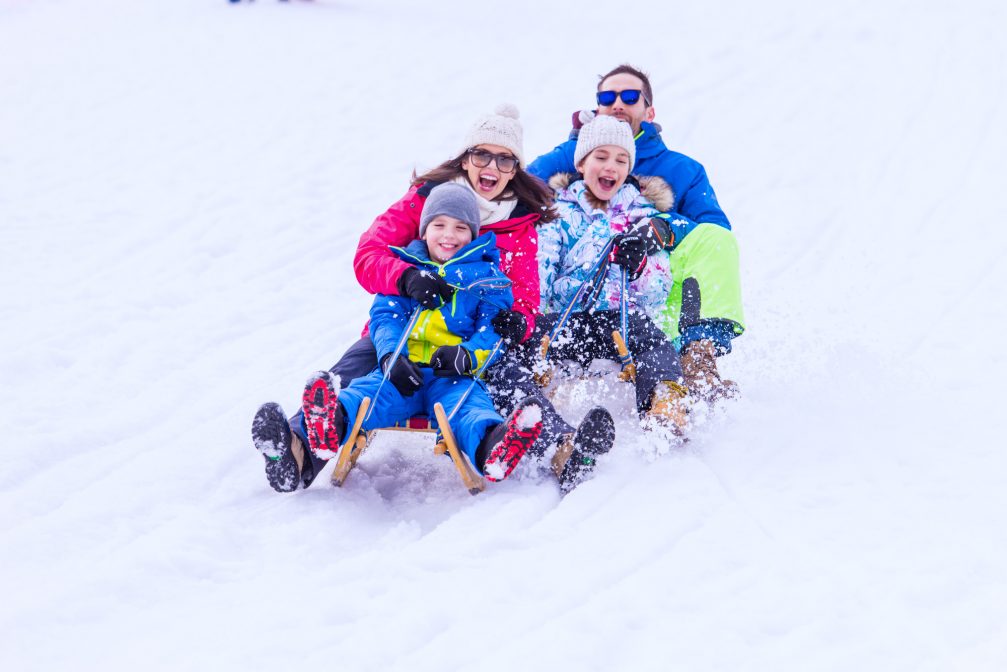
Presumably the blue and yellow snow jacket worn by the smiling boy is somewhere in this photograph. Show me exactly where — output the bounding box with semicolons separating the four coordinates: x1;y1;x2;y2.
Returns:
371;233;514;374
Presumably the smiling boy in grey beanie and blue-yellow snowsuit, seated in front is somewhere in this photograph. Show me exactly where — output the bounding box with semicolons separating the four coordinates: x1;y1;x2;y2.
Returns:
253;182;542;492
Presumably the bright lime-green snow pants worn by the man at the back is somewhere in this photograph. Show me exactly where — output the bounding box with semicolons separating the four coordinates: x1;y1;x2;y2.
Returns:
658;224;745;354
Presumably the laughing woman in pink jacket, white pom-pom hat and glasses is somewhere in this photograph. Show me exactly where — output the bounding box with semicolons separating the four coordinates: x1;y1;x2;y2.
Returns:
252;105;614;492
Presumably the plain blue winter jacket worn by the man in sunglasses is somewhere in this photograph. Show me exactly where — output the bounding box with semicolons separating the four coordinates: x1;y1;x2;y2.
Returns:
528;121;731;247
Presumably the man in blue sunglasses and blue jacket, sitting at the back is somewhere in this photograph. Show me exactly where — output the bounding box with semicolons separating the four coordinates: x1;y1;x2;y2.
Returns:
528;64;745;400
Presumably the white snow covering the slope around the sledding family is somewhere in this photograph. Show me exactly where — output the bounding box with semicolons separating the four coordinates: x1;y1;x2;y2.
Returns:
0;0;1007;672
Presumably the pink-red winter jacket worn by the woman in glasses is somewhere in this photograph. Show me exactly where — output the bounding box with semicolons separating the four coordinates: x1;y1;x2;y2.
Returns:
353;182;540;339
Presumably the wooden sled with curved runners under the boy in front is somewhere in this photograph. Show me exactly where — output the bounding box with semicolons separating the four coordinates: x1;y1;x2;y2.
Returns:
332;399;486;495
